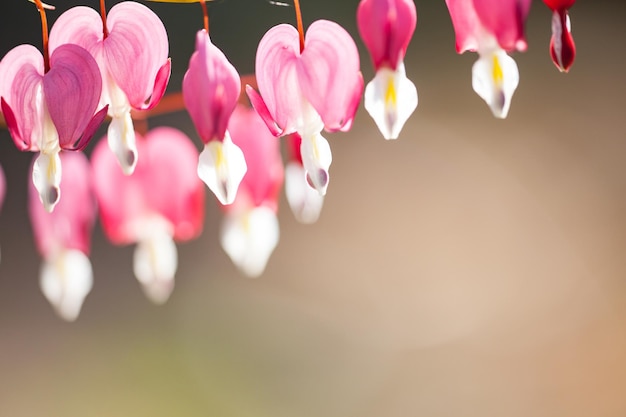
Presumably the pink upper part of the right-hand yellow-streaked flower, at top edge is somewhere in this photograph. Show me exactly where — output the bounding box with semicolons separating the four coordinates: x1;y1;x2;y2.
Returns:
473;0;531;51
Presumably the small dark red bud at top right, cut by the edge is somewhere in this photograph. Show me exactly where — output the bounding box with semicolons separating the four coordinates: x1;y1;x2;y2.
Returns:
543;0;576;72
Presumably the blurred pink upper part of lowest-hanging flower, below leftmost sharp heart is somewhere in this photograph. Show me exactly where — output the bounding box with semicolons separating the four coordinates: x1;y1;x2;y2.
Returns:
28;152;97;257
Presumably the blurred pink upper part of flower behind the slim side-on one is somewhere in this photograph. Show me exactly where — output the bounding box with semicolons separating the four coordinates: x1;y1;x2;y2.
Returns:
228;105;284;211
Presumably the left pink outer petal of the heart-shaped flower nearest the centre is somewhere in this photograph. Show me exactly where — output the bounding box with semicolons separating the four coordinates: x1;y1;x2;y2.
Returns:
253;24;302;135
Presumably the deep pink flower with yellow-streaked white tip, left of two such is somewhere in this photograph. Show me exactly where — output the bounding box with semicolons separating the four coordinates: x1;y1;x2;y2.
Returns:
357;0;417;139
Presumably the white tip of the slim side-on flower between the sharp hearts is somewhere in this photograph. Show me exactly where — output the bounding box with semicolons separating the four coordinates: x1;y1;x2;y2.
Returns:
198;131;248;205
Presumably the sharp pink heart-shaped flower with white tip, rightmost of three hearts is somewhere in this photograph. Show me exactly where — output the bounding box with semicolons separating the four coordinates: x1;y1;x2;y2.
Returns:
246;20;363;195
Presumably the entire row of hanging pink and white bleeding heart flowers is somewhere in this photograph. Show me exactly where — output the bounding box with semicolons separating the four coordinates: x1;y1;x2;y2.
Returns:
0;0;575;320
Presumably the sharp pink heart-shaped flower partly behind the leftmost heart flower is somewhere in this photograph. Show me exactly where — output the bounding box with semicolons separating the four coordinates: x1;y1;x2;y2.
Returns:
50;1;171;175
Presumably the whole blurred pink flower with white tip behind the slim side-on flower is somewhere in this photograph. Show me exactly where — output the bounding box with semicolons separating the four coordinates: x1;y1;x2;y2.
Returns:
220;105;282;277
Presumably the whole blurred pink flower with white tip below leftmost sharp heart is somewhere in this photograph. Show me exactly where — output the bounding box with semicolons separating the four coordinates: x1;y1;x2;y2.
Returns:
28;152;97;321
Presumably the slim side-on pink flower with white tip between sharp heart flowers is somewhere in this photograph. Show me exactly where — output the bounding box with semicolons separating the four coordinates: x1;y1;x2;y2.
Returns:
183;29;247;204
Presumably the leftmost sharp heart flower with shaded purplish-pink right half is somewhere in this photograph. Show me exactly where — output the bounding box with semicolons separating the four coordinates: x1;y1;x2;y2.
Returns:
0;45;106;212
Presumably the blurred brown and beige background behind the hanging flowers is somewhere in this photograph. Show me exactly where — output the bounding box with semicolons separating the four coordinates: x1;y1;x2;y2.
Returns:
0;0;626;417
